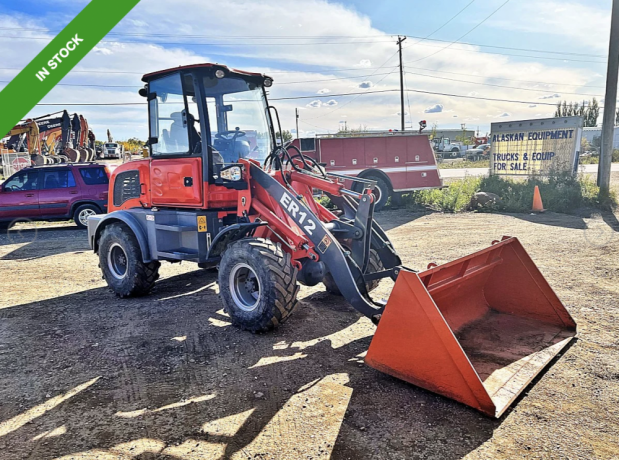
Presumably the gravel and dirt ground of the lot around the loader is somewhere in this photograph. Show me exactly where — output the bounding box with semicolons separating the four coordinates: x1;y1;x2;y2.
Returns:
0;206;619;460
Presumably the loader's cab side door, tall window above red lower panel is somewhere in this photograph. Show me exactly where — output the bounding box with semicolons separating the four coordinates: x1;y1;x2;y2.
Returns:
149;73;203;208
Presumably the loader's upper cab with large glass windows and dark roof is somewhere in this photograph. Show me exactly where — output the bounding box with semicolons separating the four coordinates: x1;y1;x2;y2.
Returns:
140;64;275;184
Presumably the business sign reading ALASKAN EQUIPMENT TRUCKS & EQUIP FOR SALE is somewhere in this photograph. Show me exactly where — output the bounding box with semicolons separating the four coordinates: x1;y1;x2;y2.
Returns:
490;117;583;176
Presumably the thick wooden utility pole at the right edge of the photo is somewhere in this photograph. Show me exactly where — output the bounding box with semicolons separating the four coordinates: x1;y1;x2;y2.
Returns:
598;0;619;192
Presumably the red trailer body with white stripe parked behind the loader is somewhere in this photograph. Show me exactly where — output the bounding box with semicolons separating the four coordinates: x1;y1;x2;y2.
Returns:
291;132;443;210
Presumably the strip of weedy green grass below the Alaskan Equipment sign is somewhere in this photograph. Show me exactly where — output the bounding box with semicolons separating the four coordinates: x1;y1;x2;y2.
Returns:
405;174;617;214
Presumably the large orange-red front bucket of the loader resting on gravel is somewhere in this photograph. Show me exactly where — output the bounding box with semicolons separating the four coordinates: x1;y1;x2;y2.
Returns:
365;237;576;418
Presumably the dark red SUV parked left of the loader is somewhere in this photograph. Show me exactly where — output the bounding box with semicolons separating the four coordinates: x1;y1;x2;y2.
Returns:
0;163;110;228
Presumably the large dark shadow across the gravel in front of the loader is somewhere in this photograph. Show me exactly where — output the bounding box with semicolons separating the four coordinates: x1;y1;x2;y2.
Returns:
0;270;500;459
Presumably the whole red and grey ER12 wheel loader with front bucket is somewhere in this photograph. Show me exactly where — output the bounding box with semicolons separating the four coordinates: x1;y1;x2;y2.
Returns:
88;64;576;417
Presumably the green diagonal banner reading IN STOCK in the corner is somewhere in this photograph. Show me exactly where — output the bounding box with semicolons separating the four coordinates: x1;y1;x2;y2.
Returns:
0;0;140;137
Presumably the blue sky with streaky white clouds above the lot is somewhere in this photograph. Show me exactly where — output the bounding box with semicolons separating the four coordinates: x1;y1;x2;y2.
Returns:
0;0;611;140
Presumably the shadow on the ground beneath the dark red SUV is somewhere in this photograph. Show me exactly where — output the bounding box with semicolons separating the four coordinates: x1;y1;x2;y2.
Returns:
0;226;89;261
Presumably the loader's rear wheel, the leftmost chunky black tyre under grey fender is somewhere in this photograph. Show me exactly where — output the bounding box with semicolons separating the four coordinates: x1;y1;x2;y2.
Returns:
99;223;161;297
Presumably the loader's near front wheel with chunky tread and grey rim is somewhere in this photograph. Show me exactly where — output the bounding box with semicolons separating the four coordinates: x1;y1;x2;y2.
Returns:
219;238;299;332
